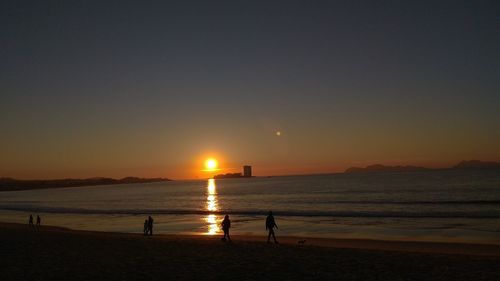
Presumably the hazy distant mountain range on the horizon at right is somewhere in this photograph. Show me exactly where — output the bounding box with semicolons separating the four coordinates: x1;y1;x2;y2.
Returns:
345;160;500;173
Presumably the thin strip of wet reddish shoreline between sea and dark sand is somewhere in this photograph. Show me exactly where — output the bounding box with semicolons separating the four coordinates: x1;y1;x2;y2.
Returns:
0;222;500;257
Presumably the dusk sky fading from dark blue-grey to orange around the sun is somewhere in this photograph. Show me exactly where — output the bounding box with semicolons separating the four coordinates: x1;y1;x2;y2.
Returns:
0;0;500;179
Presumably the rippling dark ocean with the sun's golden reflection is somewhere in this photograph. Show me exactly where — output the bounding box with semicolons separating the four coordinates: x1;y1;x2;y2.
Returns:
0;170;500;244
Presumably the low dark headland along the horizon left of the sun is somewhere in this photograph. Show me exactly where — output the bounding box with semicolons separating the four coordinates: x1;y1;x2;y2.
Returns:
0;177;170;191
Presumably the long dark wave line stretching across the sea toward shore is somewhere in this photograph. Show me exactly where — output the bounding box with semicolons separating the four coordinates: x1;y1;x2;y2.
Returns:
0;206;500;219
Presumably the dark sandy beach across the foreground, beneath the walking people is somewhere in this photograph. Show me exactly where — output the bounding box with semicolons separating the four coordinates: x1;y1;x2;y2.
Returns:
0;223;500;281
